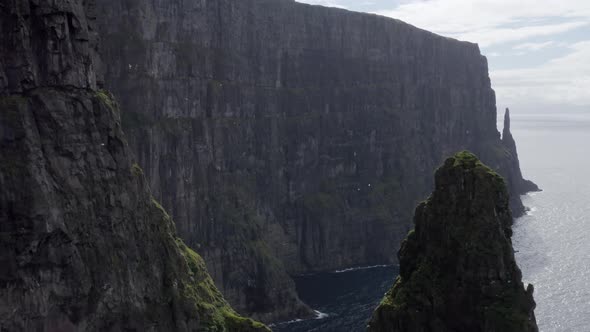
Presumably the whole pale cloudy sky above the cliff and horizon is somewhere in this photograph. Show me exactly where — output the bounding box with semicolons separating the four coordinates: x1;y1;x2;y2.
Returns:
297;0;590;112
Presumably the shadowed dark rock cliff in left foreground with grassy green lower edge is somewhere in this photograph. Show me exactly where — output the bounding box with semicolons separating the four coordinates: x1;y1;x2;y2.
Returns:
0;0;268;331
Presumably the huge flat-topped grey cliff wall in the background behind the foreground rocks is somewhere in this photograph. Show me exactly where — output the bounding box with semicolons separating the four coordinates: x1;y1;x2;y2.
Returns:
99;0;536;320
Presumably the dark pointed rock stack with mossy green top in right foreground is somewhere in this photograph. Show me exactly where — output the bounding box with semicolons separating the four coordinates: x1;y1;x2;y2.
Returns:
368;152;538;332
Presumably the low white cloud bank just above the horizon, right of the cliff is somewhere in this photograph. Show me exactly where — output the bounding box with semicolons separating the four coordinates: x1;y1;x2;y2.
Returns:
490;41;590;106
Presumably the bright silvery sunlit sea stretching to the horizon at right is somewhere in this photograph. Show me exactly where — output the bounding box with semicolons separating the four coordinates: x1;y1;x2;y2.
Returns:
512;113;590;332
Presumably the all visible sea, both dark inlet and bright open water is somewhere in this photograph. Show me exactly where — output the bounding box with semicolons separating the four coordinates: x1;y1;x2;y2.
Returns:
273;112;590;332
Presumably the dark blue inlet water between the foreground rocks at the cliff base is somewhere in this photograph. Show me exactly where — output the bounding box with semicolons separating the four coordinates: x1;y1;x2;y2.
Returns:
272;266;398;332
